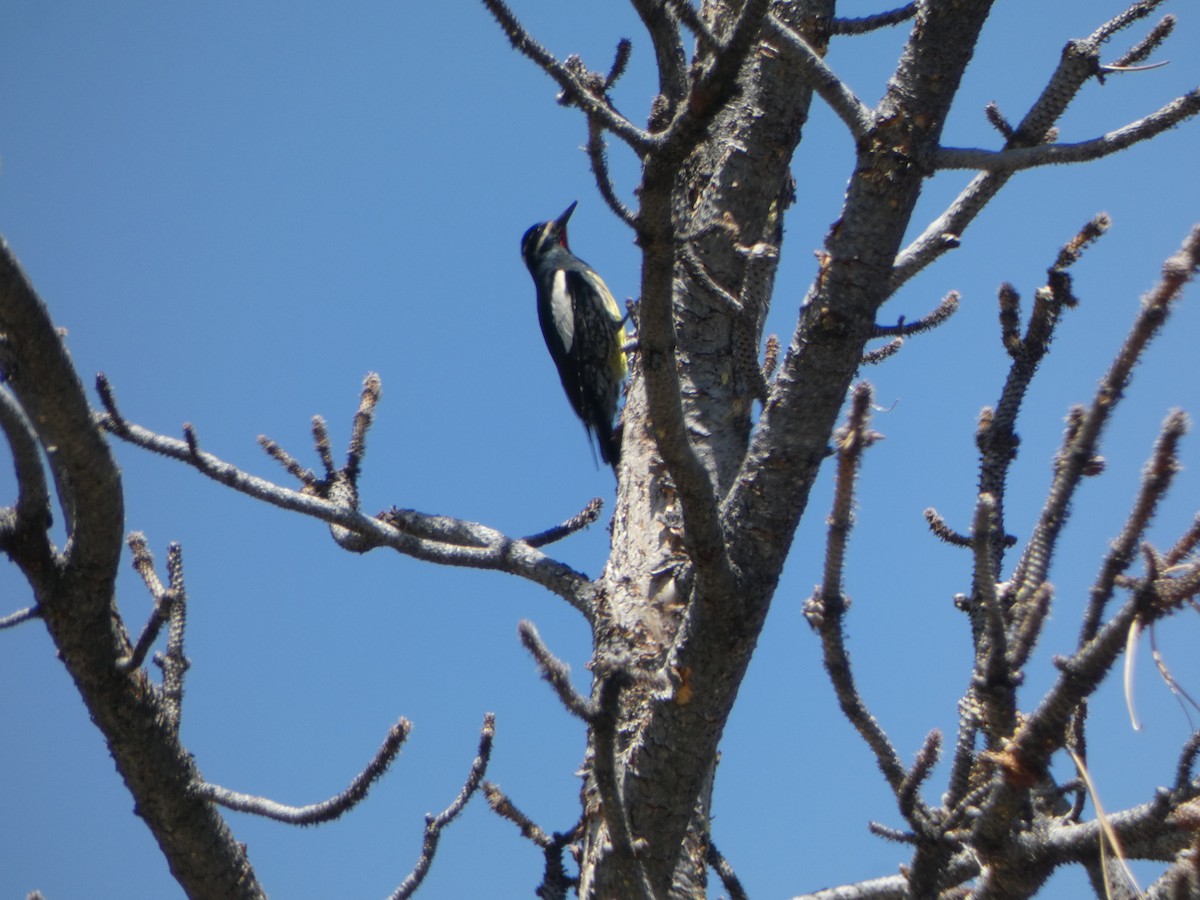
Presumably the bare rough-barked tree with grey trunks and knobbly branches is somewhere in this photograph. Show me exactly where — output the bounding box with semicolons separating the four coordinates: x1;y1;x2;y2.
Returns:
0;0;1200;896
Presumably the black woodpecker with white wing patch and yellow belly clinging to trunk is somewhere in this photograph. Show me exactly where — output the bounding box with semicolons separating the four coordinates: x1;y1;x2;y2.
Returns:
521;202;628;472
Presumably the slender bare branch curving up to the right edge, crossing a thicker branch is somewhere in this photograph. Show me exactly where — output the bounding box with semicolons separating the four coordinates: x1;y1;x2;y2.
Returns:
934;89;1200;173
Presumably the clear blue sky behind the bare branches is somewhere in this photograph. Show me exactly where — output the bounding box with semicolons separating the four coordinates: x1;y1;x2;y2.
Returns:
0;0;1200;900
